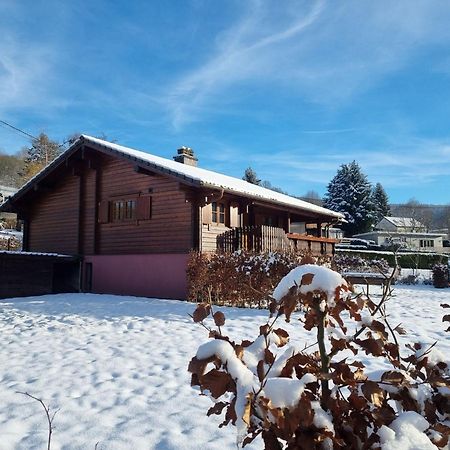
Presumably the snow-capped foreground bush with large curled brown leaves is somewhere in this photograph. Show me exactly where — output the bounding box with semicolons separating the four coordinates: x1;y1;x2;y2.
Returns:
189;264;450;450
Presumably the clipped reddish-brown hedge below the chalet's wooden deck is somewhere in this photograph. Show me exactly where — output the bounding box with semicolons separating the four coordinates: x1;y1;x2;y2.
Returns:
187;251;329;308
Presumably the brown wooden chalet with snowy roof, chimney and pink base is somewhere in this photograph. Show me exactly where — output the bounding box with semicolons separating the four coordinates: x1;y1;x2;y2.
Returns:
0;135;342;298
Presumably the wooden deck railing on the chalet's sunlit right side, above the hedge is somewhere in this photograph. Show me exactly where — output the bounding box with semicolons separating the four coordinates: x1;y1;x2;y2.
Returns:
217;225;338;255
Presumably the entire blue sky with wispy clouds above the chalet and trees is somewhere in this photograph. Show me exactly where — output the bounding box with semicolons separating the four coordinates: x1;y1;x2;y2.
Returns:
0;0;450;204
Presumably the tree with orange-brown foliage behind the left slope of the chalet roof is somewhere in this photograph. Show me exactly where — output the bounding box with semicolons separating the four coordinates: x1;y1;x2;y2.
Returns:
20;133;61;182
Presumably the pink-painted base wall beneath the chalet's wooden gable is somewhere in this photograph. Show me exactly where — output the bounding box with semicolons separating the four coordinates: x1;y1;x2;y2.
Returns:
84;254;189;299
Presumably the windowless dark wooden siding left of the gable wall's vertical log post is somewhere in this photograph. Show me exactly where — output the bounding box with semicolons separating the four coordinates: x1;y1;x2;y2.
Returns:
27;174;80;255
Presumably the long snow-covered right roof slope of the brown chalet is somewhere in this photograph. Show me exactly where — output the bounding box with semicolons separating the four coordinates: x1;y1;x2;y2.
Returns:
81;135;344;219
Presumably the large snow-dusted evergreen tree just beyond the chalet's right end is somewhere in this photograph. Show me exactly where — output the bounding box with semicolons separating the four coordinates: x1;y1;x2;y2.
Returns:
324;161;375;236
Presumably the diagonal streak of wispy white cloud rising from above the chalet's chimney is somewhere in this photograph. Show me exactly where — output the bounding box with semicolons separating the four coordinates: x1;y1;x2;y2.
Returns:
164;1;323;128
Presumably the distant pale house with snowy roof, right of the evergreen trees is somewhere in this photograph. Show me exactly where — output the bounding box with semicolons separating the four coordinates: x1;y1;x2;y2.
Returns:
354;217;445;253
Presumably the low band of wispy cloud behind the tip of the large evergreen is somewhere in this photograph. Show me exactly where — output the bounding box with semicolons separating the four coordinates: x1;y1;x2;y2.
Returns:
248;136;450;196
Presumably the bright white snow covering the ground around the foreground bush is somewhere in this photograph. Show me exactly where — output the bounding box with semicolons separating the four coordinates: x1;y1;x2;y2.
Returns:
0;286;450;450
